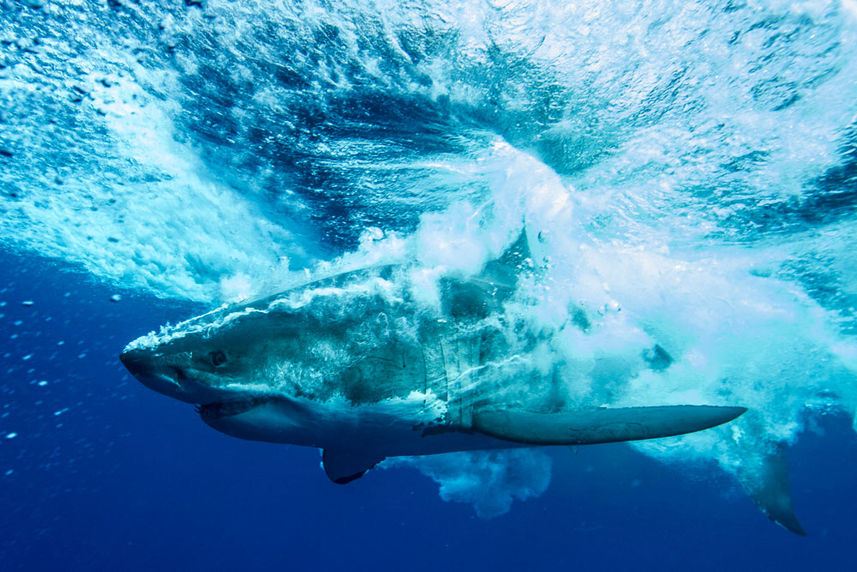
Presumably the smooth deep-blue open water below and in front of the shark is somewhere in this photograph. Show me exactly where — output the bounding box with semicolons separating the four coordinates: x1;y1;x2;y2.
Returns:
0;255;857;570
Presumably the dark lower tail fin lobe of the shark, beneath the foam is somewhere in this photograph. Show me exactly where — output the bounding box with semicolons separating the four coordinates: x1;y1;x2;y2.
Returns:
738;445;807;536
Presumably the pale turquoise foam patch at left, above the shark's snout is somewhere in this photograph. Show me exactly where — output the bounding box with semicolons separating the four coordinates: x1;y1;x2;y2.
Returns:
0;61;303;302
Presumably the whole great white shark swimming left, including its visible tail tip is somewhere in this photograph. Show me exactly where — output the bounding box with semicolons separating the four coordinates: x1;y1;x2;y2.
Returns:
120;232;803;533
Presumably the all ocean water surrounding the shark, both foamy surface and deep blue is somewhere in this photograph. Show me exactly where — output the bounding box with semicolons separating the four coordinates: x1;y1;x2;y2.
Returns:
0;0;857;570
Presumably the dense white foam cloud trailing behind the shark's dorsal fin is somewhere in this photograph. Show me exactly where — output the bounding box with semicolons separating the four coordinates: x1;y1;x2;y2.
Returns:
402;137;857;502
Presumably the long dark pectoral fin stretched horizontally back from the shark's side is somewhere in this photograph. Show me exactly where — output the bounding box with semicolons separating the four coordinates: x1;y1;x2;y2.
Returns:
473;405;746;445
